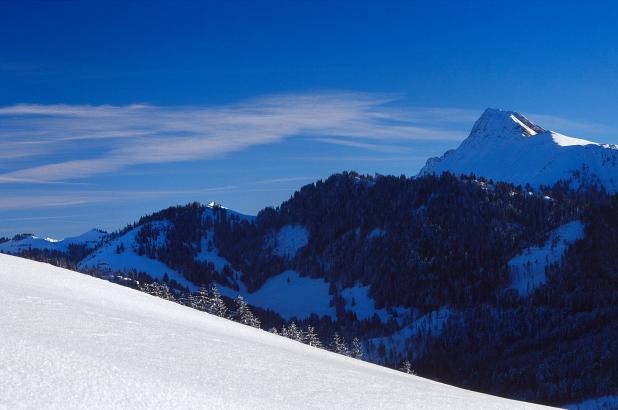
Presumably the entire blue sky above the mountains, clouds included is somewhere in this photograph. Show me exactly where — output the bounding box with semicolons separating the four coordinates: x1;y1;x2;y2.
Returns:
0;0;618;237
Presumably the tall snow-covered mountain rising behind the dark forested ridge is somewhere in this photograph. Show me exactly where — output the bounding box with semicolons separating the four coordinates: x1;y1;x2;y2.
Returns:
419;109;618;192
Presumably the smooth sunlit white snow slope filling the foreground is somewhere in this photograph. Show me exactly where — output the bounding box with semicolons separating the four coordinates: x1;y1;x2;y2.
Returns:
0;255;552;409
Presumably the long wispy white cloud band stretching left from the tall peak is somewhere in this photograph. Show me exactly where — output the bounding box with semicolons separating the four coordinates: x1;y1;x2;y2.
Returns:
0;92;476;183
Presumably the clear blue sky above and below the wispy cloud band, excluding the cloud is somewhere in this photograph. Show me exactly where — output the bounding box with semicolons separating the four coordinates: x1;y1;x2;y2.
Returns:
0;0;618;237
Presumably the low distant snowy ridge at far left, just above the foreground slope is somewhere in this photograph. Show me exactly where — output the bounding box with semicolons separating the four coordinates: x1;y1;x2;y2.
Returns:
0;229;107;253
